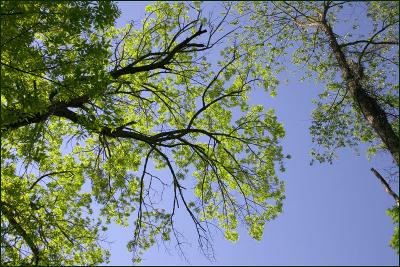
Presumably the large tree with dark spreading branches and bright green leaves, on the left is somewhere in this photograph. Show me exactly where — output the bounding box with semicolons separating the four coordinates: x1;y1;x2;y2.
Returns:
1;1;284;265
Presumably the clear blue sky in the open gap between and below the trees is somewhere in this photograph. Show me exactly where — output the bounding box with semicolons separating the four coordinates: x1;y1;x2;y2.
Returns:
101;2;399;265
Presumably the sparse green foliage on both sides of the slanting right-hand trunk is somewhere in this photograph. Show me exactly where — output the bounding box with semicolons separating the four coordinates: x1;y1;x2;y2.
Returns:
236;1;399;163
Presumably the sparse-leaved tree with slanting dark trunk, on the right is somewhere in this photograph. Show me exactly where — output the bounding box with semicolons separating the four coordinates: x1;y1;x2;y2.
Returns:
232;1;400;255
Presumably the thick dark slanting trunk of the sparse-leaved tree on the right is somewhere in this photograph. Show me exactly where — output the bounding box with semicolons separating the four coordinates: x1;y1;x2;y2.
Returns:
321;21;400;165
